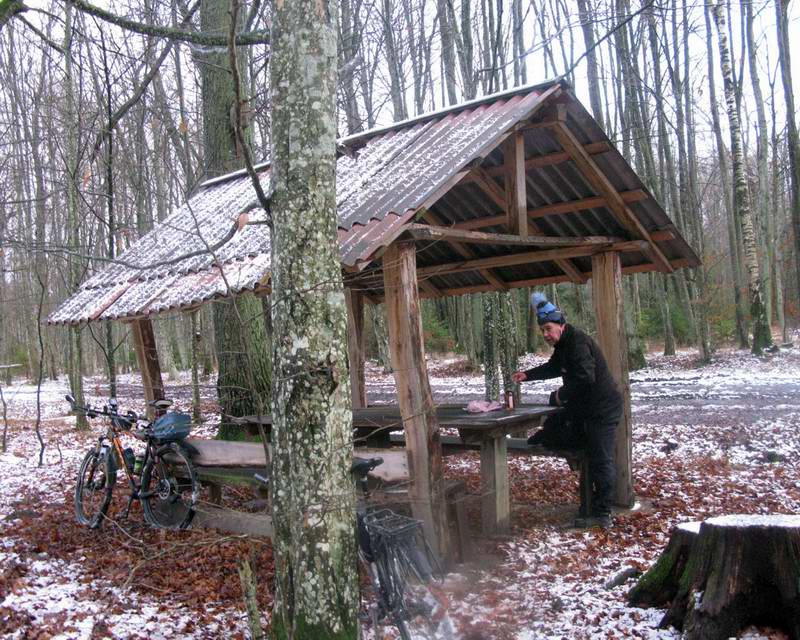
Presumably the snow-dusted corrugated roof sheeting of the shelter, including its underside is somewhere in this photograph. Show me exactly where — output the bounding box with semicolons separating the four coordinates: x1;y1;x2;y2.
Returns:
48;81;697;324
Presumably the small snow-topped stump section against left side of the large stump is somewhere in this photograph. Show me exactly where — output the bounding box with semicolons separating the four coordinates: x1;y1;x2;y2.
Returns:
628;522;700;607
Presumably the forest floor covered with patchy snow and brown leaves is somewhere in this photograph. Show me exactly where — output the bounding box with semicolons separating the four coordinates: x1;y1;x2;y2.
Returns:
0;340;800;640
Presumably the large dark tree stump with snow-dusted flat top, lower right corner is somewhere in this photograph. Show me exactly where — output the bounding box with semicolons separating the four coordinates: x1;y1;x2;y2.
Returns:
634;515;800;640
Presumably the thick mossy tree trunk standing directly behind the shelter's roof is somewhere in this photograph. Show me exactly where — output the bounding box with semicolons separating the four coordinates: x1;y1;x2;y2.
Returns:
197;0;272;438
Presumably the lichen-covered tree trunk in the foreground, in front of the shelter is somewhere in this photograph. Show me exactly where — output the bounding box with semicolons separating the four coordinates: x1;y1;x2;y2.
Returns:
270;0;358;640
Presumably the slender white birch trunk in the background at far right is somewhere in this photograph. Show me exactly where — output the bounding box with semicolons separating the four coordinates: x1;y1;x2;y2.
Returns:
714;4;772;353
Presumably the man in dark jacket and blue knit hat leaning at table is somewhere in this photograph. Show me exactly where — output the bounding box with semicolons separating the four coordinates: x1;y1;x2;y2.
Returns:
512;293;623;528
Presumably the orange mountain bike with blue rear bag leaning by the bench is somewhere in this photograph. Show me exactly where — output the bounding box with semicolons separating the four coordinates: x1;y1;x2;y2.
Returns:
66;395;200;529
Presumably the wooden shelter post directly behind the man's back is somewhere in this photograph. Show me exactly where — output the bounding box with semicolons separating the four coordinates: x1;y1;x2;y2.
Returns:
592;252;634;508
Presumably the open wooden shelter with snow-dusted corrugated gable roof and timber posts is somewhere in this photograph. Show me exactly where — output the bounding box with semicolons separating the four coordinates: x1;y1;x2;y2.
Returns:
49;79;700;540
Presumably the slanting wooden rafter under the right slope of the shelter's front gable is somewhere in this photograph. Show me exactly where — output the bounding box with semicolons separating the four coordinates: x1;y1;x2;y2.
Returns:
550;121;672;273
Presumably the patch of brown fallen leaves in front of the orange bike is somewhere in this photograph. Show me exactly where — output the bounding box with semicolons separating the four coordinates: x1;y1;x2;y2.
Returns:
0;491;274;624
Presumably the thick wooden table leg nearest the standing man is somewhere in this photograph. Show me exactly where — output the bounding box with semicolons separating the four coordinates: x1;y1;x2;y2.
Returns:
481;434;511;534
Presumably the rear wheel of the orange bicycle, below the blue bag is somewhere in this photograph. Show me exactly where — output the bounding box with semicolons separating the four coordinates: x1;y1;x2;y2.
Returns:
141;442;200;529
